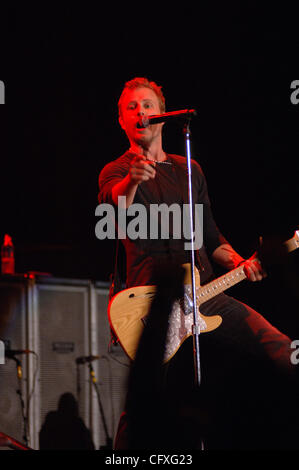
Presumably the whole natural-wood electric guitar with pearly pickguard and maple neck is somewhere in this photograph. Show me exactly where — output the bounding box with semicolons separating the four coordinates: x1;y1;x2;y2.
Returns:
108;230;299;362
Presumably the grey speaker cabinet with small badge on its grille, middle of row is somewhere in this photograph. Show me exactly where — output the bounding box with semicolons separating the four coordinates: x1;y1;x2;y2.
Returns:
33;279;91;449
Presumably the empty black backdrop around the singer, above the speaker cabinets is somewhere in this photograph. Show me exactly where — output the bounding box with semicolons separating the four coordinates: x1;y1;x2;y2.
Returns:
0;2;299;336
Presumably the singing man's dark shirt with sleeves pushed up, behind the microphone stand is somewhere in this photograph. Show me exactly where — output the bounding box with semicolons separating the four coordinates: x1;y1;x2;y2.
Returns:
99;151;227;287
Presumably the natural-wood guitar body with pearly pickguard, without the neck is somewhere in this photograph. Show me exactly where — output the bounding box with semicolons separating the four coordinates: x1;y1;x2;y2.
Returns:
108;264;222;362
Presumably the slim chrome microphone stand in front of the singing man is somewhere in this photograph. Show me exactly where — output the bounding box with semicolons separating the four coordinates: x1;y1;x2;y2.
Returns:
183;116;201;386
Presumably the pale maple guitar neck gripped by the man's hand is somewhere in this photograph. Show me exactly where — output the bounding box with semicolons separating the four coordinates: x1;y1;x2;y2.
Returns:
198;230;299;304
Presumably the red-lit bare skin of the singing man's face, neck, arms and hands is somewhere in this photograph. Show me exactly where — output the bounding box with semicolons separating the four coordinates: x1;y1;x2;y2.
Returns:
112;87;265;282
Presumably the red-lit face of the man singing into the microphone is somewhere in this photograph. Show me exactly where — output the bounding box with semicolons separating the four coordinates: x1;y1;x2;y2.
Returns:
119;88;163;145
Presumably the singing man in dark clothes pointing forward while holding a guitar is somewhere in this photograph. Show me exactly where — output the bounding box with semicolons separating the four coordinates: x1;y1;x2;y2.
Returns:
99;78;294;449
